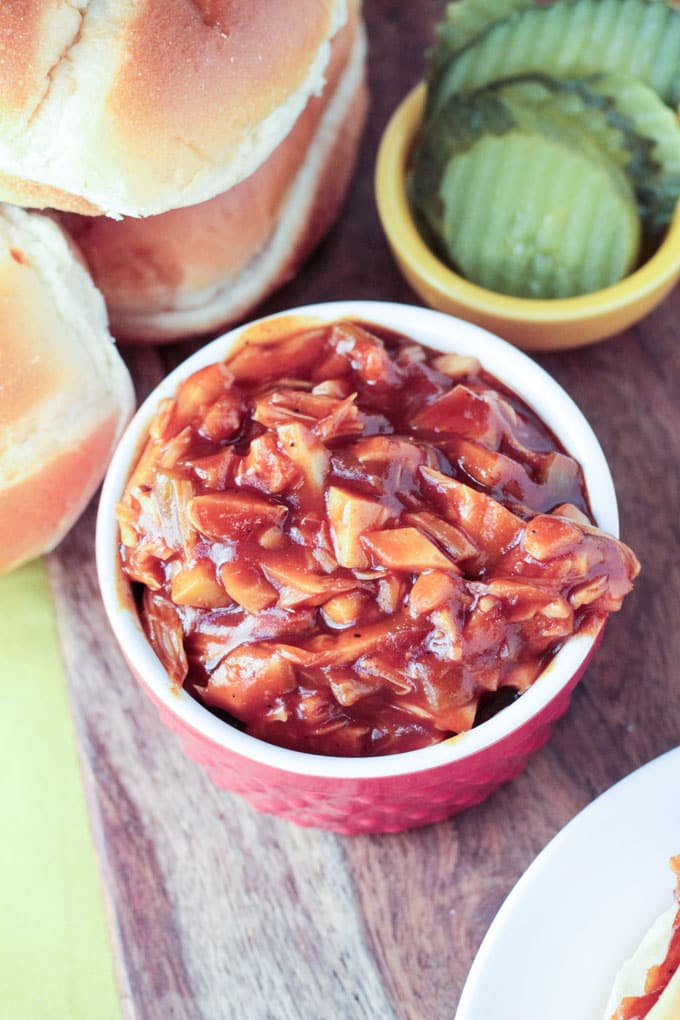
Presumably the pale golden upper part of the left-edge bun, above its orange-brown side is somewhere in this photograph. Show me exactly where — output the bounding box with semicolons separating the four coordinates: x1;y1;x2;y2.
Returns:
0;206;134;492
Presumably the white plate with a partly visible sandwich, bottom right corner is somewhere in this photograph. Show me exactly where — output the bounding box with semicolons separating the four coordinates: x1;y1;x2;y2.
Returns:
456;748;680;1020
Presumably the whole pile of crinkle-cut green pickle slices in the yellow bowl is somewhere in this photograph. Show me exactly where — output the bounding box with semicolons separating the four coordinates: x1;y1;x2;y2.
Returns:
408;0;680;298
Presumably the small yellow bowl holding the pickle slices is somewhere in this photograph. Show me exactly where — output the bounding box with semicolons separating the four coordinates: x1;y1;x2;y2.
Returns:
375;84;680;351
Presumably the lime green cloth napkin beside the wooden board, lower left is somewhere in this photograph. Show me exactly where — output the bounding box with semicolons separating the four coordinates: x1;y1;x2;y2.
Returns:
0;560;120;1020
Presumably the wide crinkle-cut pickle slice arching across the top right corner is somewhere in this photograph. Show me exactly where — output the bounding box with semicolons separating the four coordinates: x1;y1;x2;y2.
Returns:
428;0;680;112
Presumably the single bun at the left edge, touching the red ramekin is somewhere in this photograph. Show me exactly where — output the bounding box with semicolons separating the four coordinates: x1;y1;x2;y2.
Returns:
0;206;134;571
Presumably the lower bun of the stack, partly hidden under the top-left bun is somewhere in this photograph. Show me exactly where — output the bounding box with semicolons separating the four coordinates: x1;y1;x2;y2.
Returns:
61;3;367;342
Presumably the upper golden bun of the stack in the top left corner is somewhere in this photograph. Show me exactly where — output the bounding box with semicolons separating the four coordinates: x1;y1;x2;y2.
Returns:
0;0;347;216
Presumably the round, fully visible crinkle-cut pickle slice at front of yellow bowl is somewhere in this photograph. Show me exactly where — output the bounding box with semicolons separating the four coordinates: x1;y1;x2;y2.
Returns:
440;130;640;298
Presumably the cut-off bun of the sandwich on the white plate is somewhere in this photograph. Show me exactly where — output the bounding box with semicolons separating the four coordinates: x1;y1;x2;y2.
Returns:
603;904;680;1020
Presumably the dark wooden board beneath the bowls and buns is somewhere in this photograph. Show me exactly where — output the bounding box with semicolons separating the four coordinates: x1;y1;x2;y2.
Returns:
50;0;680;1020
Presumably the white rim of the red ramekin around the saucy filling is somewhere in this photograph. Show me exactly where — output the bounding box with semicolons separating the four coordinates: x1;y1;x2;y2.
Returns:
96;301;619;779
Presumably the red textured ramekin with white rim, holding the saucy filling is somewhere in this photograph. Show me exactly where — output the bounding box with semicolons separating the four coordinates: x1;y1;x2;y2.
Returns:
97;301;618;833
